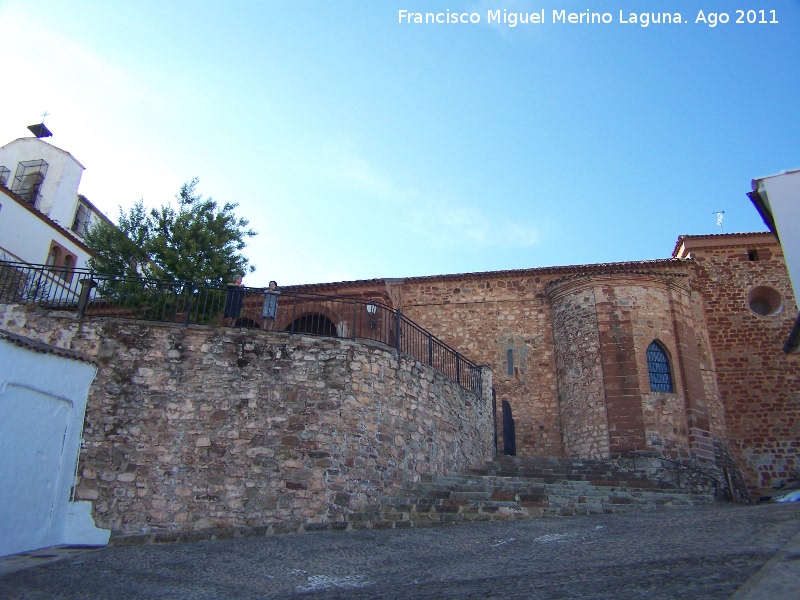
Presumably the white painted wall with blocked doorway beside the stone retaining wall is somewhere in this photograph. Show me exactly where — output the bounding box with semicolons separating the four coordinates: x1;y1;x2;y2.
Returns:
0;337;110;556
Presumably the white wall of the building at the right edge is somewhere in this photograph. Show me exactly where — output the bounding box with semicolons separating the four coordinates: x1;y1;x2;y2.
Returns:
753;169;800;298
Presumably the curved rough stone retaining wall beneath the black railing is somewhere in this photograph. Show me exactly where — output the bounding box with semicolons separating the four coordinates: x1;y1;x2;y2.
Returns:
0;305;493;534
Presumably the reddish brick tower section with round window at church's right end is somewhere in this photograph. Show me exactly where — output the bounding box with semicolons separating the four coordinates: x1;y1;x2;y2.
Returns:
675;234;800;496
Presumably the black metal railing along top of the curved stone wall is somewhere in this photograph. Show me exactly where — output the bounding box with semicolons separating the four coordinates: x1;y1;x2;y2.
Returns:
0;261;482;393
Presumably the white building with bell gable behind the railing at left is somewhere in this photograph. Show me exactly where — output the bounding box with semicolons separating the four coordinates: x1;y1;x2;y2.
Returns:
0;132;108;278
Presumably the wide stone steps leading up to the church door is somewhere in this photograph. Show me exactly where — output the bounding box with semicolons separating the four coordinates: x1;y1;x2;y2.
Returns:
348;457;715;529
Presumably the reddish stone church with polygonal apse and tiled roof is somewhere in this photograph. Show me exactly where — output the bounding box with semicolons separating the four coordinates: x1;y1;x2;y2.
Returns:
292;233;800;497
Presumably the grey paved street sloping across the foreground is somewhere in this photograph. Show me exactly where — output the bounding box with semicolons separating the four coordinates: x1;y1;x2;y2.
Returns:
0;504;800;600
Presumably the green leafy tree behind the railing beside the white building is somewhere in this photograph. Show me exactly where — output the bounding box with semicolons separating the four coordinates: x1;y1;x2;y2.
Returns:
85;178;256;285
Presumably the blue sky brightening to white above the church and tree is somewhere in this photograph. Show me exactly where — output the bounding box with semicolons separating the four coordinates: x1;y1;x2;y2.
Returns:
0;0;800;286
